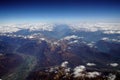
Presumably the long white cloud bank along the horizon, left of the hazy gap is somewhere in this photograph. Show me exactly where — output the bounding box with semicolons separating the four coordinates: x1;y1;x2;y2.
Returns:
0;23;54;33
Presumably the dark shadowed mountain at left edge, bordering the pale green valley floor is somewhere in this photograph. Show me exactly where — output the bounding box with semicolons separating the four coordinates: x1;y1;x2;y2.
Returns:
0;53;23;77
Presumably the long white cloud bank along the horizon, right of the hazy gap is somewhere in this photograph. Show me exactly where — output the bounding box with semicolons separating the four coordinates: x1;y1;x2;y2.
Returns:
68;22;120;34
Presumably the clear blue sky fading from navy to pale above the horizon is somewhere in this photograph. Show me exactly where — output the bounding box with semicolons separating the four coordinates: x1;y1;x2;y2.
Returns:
0;0;120;24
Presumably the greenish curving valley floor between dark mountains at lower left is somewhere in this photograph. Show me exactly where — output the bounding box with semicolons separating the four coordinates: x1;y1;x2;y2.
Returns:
2;54;37;80
